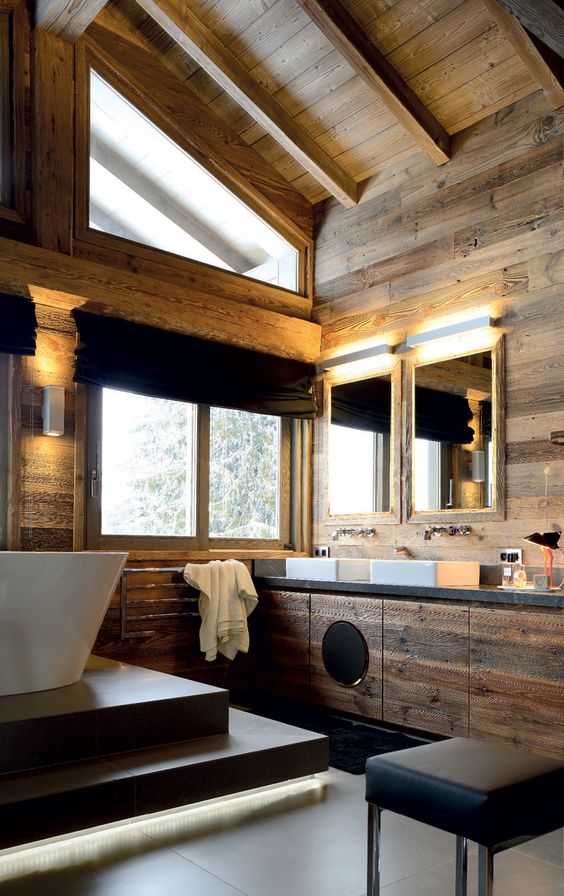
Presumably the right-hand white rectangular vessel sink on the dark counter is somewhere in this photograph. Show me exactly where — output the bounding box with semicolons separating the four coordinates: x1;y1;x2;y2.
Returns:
370;560;480;588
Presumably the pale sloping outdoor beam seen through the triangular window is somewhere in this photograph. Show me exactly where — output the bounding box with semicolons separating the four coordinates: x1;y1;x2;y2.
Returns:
90;134;256;273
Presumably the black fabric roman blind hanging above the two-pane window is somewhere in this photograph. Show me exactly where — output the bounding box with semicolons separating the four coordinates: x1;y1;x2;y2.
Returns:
73;310;315;419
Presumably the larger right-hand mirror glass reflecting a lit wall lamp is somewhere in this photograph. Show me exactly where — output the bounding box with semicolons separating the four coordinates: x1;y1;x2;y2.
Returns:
410;338;502;518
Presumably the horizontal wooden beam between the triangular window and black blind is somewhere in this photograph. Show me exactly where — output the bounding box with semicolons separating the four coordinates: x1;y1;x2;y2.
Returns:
0;238;321;362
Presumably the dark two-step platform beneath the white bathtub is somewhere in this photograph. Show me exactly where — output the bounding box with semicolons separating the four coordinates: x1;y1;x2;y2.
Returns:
0;658;328;848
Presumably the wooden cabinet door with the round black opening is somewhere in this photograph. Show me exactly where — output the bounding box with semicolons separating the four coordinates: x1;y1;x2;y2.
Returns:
310;594;382;719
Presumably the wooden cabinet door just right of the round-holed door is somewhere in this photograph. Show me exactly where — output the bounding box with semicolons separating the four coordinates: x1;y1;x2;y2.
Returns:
383;600;469;735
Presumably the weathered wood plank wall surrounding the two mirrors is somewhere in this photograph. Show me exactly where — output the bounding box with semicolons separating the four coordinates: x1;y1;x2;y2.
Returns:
313;93;564;581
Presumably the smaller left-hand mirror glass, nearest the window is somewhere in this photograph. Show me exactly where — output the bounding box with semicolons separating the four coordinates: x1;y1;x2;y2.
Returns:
328;368;399;517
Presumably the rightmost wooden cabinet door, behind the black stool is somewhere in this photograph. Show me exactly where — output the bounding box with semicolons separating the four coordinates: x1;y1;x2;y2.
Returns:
470;608;564;758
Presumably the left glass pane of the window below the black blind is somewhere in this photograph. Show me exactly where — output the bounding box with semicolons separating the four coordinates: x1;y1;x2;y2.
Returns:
102;389;196;536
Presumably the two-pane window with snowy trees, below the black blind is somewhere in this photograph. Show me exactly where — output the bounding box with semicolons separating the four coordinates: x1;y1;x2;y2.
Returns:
88;388;289;547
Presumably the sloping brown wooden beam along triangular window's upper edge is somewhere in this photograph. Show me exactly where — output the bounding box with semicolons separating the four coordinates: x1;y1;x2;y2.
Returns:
83;23;313;245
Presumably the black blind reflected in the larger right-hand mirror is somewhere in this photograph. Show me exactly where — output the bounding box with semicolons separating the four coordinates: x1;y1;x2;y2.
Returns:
415;386;474;445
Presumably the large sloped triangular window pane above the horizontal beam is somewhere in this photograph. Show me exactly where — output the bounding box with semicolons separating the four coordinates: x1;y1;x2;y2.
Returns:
90;71;298;290
